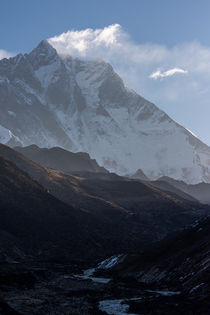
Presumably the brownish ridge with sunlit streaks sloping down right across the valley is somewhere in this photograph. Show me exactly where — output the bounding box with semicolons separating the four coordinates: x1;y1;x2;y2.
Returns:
0;145;208;253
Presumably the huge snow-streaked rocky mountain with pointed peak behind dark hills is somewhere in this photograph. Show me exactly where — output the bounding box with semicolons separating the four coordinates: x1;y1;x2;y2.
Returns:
0;40;210;183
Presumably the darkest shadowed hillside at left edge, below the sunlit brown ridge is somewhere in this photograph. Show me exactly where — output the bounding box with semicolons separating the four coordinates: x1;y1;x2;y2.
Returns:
0;157;81;251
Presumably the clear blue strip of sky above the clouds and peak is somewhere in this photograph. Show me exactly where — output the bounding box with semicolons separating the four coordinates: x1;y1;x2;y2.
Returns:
0;0;210;52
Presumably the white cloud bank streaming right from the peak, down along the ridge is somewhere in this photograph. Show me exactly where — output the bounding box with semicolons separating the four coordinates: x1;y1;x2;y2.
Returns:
46;24;210;144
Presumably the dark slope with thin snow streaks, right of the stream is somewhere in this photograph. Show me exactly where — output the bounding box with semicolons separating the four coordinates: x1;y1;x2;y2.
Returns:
98;218;210;315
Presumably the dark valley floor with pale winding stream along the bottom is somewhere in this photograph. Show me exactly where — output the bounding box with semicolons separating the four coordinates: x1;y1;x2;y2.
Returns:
0;263;208;315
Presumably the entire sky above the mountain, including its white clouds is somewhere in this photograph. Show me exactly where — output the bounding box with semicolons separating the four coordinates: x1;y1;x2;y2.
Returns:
0;0;210;145
